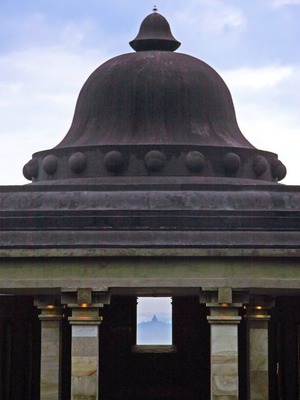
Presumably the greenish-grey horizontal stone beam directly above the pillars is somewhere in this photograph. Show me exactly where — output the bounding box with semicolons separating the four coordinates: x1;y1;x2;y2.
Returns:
0;256;300;294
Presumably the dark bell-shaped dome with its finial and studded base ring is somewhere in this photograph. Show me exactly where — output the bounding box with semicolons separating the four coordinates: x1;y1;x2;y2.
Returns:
24;12;285;182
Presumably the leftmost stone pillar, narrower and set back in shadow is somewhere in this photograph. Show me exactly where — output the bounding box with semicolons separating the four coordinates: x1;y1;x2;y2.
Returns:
35;299;63;400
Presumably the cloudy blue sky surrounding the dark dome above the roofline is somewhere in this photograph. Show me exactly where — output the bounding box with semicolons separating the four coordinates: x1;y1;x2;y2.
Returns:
0;0;300;185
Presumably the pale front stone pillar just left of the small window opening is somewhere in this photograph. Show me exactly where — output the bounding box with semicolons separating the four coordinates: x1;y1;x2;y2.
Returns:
63;289;108;400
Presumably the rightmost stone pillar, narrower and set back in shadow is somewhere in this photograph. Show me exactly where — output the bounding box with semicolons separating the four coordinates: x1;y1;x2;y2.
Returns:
246;298;272;400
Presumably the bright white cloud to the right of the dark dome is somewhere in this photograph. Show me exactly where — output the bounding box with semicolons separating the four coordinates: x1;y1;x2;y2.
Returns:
221;65;300;184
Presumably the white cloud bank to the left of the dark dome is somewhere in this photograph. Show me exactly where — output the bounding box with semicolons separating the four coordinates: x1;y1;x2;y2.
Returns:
0;47;109;184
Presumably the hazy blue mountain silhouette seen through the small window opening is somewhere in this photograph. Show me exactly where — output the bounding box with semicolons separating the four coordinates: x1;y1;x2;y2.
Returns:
137;315;172;344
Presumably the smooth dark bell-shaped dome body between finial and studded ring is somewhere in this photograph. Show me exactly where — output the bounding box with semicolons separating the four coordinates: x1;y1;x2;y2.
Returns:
57;51;253;148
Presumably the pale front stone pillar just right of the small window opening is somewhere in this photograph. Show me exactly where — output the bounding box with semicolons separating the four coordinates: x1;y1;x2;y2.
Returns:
204;288;243;400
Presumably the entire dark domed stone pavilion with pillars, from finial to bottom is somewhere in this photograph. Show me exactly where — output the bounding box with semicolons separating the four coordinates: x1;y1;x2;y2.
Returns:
0;11;300;400
